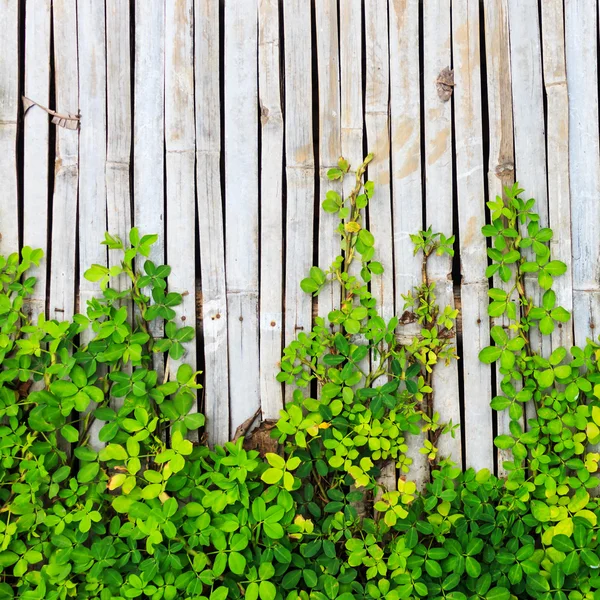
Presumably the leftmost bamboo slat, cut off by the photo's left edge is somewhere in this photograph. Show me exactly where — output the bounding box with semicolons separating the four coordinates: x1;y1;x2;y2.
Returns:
0;0;19;255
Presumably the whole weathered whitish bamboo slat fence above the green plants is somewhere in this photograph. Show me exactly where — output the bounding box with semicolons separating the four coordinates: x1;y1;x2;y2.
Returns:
0;0;600;480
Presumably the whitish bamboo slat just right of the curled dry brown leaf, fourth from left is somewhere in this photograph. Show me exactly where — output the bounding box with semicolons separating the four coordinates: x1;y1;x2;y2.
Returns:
78;0;107;316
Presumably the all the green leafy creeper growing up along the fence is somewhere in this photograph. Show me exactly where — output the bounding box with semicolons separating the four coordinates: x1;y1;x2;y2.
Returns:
0;166;600;600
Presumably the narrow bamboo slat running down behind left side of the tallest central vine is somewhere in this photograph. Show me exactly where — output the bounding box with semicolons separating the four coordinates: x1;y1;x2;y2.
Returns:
315;0;342;324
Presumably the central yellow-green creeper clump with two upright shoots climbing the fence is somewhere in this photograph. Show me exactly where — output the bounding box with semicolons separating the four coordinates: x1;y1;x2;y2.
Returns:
273;155;458;492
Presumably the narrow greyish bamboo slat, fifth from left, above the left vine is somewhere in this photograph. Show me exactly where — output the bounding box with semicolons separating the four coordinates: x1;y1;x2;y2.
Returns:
106;0;131;289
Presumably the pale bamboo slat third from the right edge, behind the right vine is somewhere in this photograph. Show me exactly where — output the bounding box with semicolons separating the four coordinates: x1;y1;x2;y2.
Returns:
508;0;551;366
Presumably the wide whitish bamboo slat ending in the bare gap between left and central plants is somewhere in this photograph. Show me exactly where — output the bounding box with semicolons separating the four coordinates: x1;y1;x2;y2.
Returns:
225;2;260;434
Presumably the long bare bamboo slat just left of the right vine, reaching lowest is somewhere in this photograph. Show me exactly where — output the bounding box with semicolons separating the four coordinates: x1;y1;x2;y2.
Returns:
452;0;494;470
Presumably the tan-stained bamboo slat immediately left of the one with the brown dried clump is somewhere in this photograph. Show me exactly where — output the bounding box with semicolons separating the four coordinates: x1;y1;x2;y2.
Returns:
390;2;429;489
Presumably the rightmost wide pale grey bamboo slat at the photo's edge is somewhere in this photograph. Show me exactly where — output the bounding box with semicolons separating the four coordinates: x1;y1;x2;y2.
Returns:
565;0;600;346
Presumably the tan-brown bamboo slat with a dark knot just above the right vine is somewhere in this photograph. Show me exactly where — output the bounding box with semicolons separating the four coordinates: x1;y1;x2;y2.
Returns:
484;0;524;477
